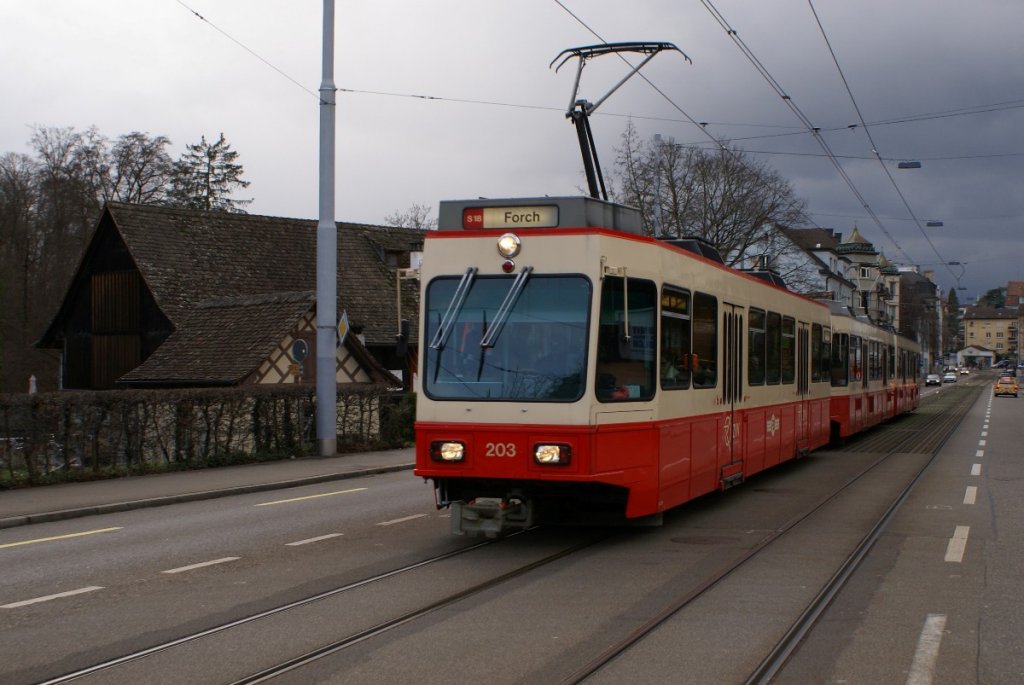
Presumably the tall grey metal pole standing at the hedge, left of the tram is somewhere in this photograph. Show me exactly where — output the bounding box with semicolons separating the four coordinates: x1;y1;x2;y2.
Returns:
316;0;338;457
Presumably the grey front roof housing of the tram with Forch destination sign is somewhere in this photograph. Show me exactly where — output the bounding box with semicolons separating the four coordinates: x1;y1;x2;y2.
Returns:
437;197;643;234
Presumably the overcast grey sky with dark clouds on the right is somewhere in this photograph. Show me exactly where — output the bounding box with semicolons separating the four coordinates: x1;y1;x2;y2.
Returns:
0;0;1024;301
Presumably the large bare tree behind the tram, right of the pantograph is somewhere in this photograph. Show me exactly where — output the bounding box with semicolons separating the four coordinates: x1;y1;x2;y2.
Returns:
616;123;805;265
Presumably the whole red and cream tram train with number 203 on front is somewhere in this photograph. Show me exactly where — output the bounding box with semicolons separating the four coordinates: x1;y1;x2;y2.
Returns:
416;197;918;534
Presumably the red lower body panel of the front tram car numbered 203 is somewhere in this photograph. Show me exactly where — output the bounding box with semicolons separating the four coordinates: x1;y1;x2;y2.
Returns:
415;399;829;518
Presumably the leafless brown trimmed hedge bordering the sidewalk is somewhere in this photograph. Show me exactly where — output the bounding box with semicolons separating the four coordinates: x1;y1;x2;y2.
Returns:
0;385;415;488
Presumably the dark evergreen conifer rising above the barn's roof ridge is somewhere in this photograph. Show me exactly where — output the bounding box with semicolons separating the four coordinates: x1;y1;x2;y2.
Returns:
167;133;252;212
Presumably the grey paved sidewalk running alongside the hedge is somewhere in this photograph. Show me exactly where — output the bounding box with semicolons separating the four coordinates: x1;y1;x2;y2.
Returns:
0;447;416;528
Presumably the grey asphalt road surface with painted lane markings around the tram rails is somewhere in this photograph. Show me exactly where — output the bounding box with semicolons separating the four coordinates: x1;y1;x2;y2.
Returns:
0;376;1024;685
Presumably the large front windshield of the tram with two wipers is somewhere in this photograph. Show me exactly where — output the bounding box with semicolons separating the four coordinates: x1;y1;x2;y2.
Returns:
421;275;591;401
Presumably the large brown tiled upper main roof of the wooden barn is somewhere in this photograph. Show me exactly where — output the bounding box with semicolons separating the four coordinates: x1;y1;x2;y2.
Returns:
106;203;423;344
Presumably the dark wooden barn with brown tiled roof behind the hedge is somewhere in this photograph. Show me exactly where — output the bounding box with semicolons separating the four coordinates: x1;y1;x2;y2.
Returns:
37;203;423;389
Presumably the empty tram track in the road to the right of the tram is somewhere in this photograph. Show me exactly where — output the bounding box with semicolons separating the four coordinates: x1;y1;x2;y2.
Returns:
560;386;983;685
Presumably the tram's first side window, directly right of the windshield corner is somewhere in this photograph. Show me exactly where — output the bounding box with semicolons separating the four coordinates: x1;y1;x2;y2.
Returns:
595;276;657;401
